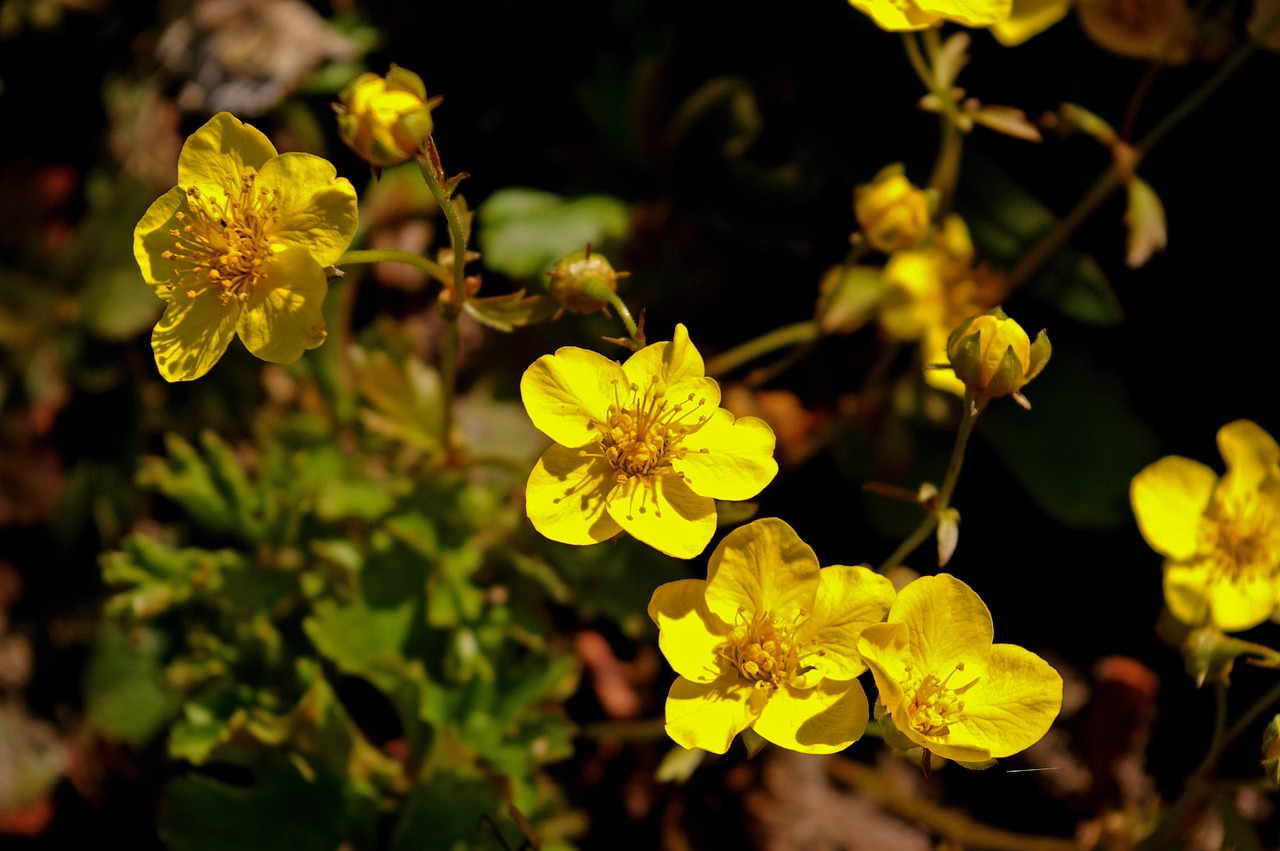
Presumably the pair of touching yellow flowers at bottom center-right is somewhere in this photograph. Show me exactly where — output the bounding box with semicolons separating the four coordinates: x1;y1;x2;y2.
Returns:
649;518;1062;763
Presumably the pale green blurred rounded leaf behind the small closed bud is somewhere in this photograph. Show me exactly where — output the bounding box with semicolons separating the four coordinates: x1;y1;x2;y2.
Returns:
477;187;630;283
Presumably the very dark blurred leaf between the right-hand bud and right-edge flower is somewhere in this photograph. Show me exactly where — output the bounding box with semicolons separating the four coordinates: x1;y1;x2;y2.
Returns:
978;347;1160;529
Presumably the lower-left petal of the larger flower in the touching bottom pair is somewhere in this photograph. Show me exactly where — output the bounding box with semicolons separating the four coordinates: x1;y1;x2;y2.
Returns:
667;672;765;754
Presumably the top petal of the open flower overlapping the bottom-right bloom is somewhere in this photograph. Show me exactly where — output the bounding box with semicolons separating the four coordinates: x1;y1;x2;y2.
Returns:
707;517;820;623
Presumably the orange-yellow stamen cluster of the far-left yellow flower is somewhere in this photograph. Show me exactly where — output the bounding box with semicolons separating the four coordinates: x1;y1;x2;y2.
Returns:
161;169;280;305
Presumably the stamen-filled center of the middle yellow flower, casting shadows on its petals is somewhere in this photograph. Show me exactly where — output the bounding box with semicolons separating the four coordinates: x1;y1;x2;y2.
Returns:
594;375;707;484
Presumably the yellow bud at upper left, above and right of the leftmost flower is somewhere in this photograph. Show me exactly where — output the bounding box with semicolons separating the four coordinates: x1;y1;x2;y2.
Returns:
335;64;440;168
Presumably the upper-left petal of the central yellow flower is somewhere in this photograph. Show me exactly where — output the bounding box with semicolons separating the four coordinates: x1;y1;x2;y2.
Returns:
520;346;627;447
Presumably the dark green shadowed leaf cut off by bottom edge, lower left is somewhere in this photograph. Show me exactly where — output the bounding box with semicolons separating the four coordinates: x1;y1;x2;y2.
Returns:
156;752;350;851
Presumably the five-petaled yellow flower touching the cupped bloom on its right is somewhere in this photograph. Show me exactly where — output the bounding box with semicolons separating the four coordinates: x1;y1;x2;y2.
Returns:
649;518;893;754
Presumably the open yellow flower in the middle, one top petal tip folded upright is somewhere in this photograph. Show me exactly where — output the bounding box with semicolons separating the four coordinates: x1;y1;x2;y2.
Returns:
520;325;778;558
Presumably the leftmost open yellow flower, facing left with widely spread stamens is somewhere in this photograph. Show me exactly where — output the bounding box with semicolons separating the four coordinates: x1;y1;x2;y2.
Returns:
133;113;357;381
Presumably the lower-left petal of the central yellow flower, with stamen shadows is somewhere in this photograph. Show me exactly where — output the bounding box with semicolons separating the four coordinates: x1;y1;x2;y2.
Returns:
525;444;622;545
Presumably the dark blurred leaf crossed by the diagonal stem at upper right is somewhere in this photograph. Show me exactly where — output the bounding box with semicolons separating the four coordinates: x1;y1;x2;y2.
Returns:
957;155;1124;326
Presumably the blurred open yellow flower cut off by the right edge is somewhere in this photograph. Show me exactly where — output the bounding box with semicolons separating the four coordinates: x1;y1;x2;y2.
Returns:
1129;420;1280;632
